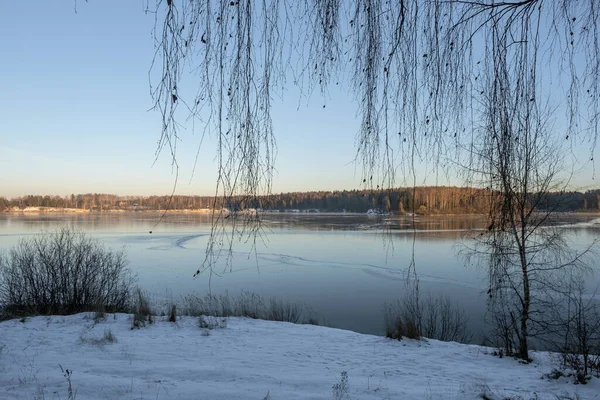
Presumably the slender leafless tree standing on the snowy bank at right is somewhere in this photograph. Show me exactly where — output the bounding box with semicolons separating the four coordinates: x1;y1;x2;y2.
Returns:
467;50;589;360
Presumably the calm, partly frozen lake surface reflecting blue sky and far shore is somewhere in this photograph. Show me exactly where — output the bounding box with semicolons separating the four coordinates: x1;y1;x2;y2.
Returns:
0;213;600;340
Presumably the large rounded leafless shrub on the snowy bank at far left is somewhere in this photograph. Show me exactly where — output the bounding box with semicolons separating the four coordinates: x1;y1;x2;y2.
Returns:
0;228;135;316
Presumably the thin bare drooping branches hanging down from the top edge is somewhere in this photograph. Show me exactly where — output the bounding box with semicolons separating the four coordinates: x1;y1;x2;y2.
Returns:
146;0;600;274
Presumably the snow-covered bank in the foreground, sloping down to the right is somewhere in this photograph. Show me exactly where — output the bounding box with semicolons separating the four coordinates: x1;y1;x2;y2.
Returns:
0;313;600;400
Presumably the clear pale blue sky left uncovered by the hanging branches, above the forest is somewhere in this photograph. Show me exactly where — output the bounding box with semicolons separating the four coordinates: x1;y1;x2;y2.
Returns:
0;0;595;197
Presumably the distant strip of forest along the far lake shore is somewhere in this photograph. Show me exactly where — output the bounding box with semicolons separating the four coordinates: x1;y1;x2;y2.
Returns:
0;186;600;214
